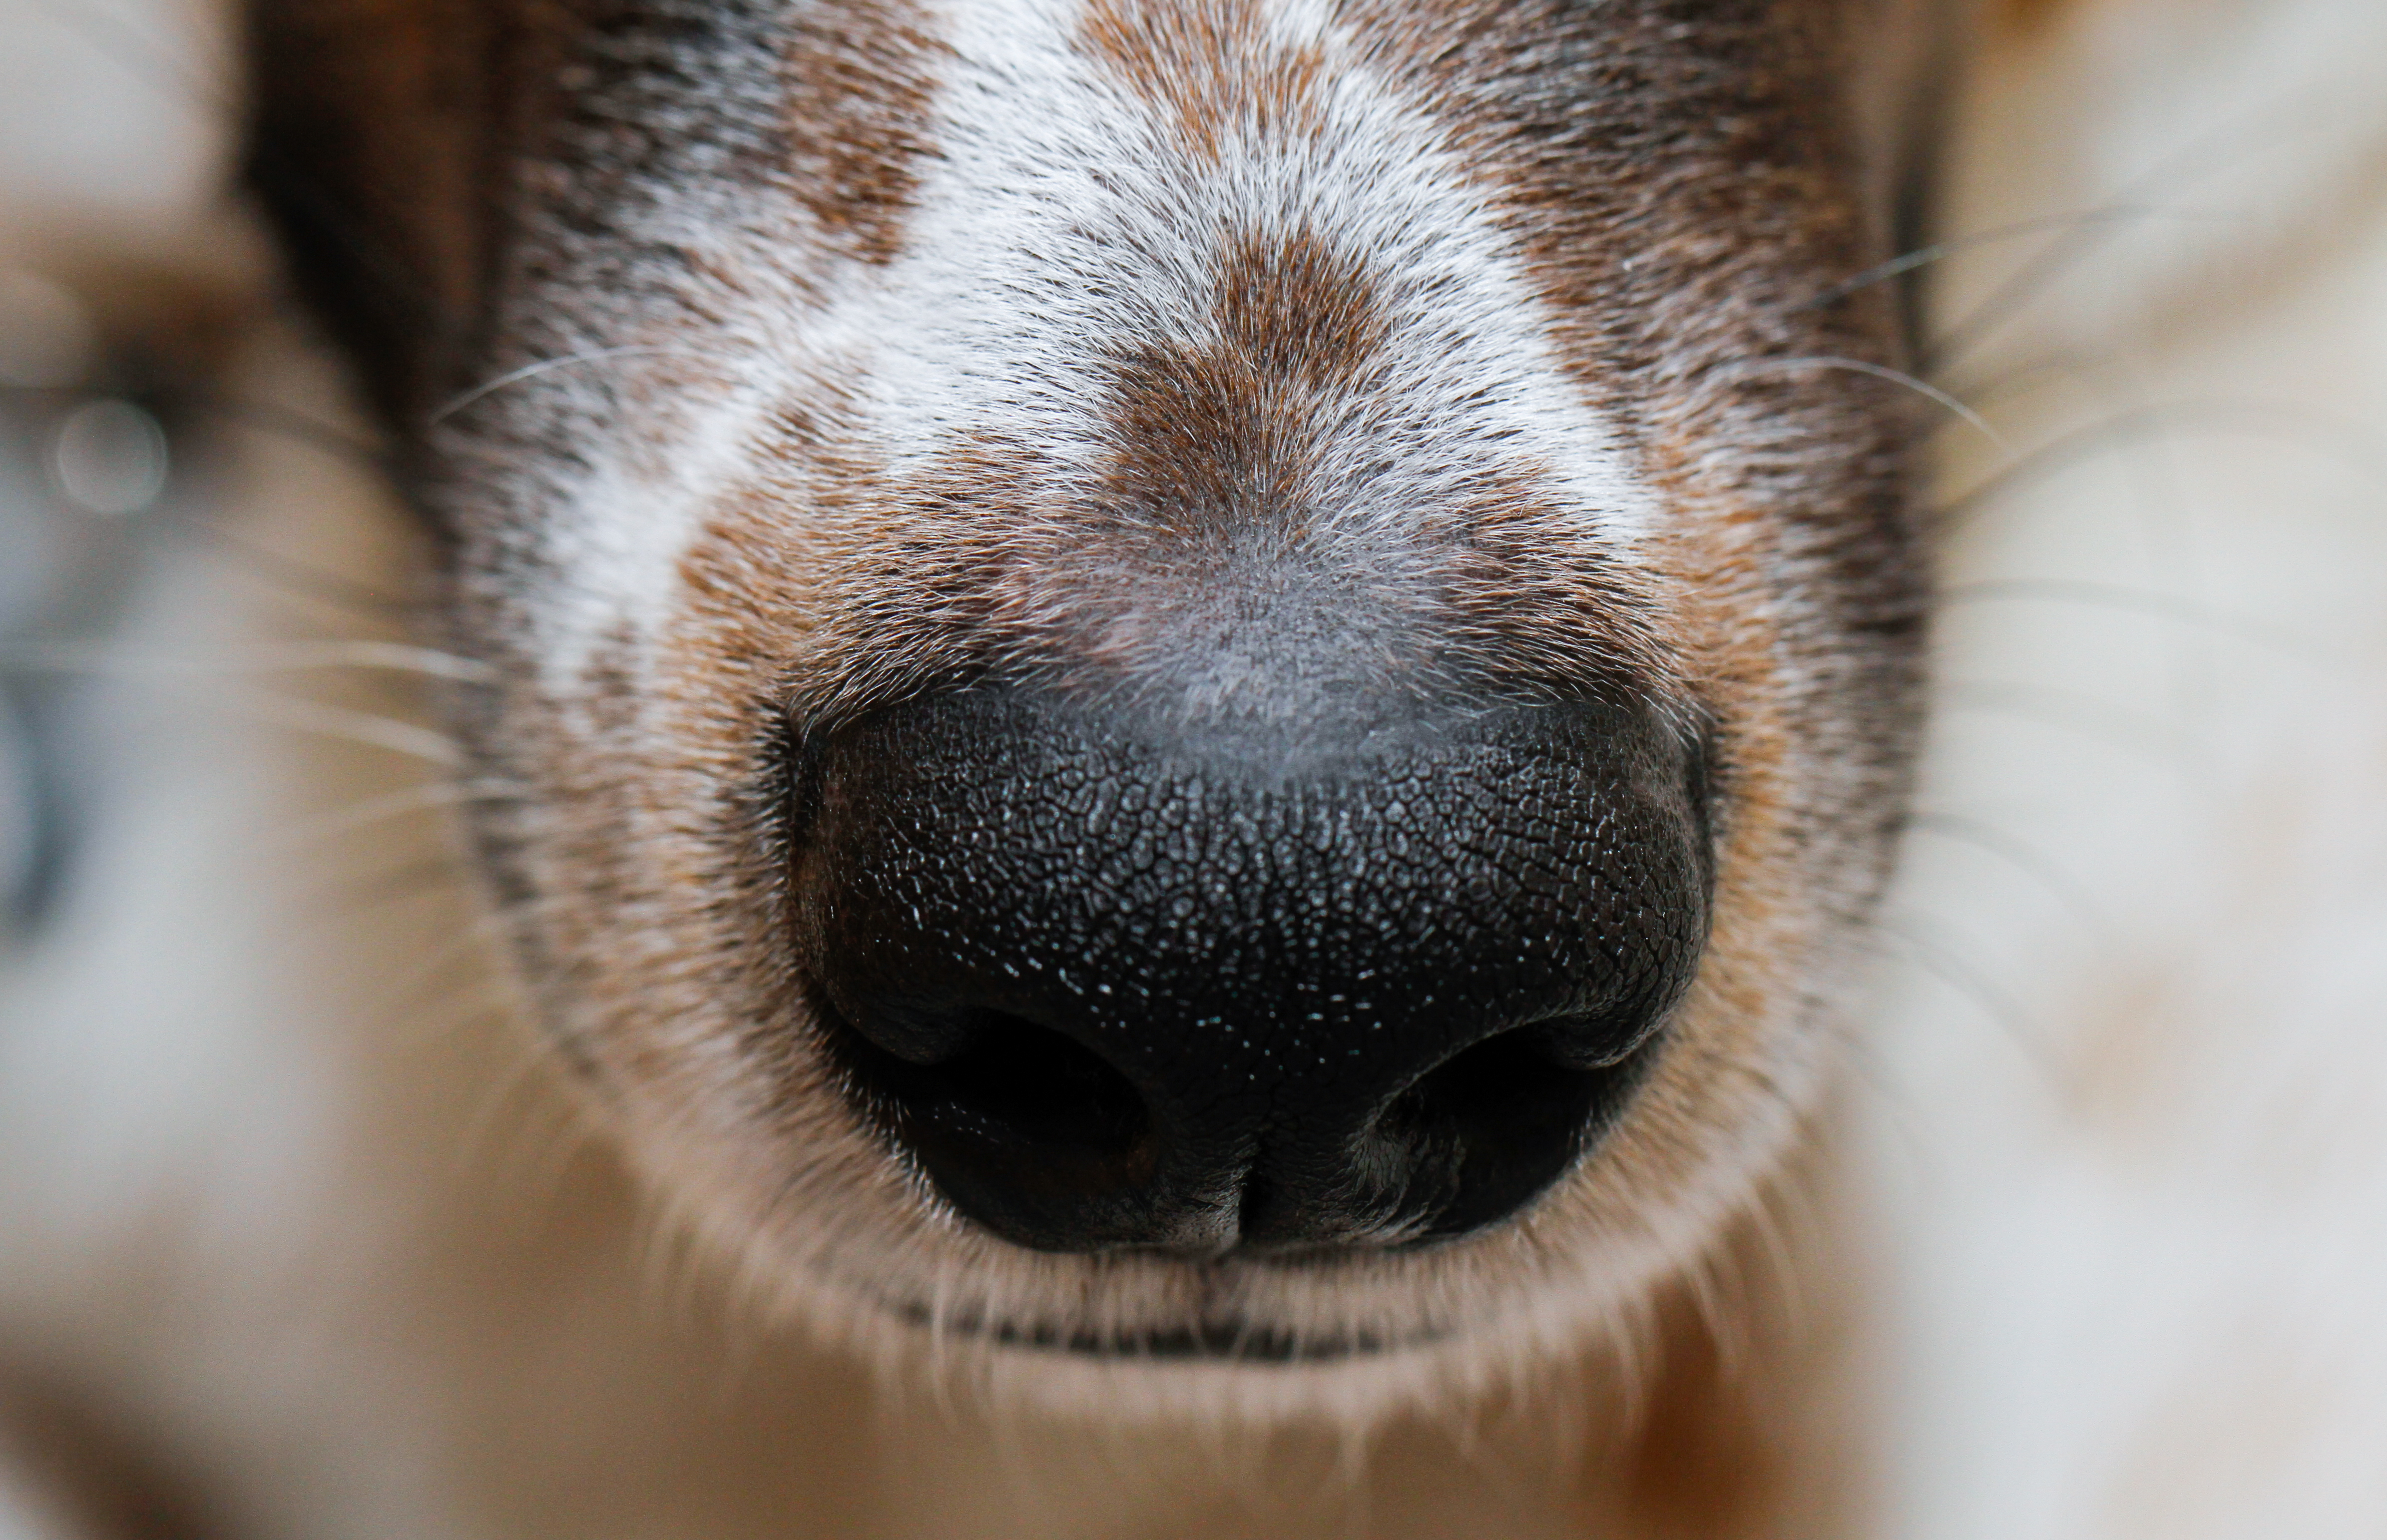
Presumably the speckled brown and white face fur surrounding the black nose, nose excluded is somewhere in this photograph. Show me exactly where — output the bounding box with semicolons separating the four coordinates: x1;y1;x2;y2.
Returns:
242;0;1928;1404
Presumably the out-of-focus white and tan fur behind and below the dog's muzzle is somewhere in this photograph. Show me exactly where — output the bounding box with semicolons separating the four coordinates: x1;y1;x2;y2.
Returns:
0;0;2387;1540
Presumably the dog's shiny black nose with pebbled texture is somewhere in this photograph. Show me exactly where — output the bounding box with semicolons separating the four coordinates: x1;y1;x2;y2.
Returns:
795;690;1709;1253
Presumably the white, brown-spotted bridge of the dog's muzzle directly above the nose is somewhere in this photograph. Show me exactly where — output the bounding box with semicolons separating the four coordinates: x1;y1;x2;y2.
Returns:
797;43;1664;740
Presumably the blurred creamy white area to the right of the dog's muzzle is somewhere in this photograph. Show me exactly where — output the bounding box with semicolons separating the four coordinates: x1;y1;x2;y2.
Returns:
1867;0;2387;1540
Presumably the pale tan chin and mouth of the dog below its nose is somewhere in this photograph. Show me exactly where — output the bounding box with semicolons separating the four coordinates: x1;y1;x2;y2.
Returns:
625;1127;1692;1428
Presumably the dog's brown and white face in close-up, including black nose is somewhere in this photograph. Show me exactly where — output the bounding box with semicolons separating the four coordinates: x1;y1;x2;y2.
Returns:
255;0;1919;1380
